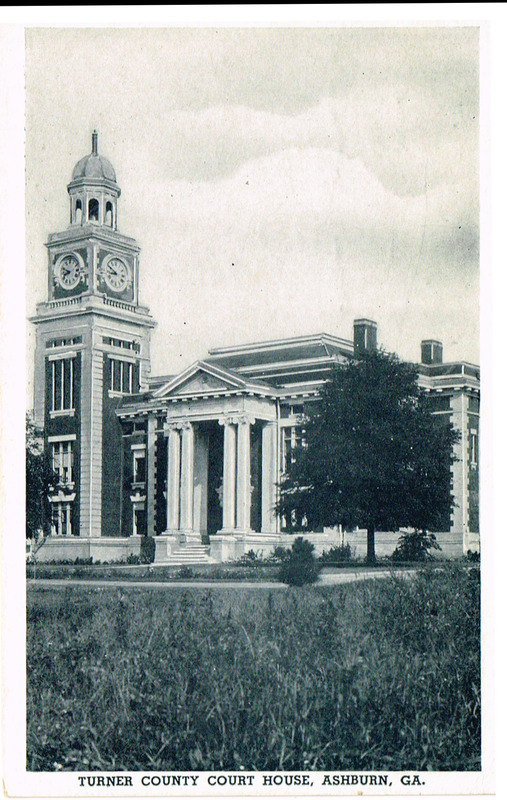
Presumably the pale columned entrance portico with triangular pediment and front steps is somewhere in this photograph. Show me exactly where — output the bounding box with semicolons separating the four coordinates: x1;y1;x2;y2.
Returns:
152;363;278;561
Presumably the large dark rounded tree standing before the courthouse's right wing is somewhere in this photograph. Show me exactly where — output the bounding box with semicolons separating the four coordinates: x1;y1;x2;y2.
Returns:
278;350;458;563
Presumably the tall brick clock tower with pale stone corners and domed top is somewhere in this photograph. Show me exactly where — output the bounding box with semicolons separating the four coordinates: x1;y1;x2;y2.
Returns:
31;132;155;558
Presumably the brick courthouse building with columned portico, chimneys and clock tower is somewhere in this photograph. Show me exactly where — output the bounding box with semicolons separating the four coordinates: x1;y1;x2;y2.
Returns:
31;133;480;563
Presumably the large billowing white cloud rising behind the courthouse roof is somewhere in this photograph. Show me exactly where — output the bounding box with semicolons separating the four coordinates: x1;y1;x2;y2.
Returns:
125;147;478;372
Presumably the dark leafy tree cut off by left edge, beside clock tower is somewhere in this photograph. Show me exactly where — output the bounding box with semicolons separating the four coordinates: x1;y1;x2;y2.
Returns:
26;414;58;538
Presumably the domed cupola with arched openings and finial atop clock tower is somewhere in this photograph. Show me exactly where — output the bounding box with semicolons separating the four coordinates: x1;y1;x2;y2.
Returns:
67;131;121;230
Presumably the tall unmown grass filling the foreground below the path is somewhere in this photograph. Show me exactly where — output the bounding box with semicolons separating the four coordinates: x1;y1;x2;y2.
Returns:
27;568;480;770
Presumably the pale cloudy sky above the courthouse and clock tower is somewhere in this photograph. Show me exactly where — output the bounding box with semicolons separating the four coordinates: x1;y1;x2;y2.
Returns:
25;26;479;404
